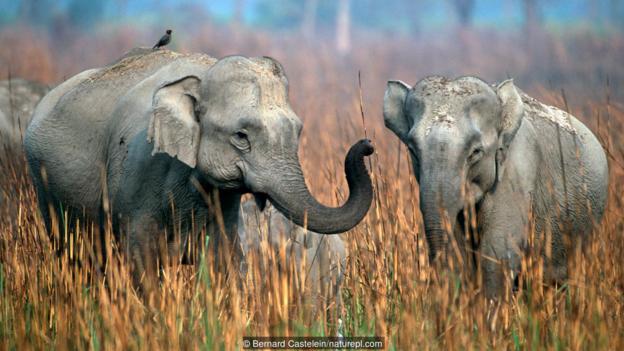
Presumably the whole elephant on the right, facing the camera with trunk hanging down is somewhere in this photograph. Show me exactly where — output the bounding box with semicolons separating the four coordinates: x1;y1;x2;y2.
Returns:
384;77;608;296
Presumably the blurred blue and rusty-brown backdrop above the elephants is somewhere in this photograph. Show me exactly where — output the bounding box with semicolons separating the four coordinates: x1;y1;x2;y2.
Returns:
0;0;624;154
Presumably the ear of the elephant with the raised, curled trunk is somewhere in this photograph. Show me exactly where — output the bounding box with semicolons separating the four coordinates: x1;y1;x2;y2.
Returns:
147;76;201;168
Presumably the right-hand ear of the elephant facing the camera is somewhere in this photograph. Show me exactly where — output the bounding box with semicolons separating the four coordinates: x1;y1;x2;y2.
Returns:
496;79;524;181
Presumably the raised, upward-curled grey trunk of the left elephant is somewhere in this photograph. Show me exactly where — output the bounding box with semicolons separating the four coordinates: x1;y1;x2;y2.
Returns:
267;140;374;234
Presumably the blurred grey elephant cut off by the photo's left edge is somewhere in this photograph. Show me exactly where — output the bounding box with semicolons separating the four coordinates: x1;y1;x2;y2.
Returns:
0;78;49;147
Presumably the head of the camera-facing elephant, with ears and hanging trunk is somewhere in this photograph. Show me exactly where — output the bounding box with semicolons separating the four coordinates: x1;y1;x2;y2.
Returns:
383;77;524;260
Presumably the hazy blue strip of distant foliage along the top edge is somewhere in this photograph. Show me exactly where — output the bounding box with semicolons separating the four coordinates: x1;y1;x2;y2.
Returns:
0;0;624;37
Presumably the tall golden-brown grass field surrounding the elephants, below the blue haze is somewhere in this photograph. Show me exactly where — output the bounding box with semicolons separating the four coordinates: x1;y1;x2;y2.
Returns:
0;26;624;350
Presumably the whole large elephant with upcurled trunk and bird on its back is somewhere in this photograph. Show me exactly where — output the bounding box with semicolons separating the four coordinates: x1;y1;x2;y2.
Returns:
24;48;374;284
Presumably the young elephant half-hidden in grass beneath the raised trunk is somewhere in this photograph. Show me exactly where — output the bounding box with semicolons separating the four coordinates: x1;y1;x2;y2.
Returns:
238;201;347;311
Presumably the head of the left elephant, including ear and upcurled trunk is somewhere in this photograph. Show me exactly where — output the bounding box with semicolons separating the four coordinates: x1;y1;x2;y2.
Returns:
148;56;373;233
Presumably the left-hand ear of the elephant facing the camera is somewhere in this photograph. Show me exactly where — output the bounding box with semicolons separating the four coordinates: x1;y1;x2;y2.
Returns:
383;80;411;142
